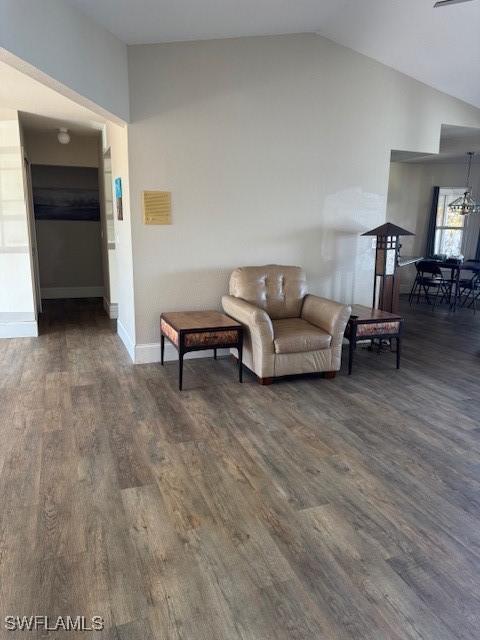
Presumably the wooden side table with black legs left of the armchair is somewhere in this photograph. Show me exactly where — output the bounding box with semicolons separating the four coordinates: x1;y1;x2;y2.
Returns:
160;311;243;391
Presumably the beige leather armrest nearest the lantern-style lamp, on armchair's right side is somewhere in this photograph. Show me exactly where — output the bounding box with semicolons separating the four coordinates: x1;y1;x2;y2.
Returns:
302;295;352;352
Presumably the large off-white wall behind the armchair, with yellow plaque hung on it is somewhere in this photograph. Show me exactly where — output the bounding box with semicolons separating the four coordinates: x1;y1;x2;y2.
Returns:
128;35;480;354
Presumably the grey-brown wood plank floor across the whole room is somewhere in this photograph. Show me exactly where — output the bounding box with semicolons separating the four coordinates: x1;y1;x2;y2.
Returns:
0;302;480;640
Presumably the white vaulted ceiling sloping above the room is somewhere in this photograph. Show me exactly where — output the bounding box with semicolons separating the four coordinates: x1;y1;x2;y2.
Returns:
65;0;480;107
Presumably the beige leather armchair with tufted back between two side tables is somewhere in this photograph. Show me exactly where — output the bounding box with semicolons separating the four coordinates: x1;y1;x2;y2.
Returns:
222;265;351;384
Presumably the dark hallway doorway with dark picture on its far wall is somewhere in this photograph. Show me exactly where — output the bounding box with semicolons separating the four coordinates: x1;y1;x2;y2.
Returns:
21;113;115;330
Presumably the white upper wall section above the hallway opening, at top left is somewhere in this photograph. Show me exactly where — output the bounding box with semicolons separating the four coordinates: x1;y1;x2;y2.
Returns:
0;0;129;120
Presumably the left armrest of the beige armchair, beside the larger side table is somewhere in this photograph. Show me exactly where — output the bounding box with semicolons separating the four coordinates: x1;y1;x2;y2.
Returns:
222;296;274;353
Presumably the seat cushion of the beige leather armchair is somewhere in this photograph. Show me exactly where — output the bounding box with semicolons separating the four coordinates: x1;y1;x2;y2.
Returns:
272;318;332;353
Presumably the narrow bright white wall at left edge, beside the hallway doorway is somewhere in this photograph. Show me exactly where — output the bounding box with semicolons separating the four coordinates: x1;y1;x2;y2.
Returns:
0;111;37;338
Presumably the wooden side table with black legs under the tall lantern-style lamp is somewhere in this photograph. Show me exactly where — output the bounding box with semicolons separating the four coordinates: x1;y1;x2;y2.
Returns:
345;304;403;375
